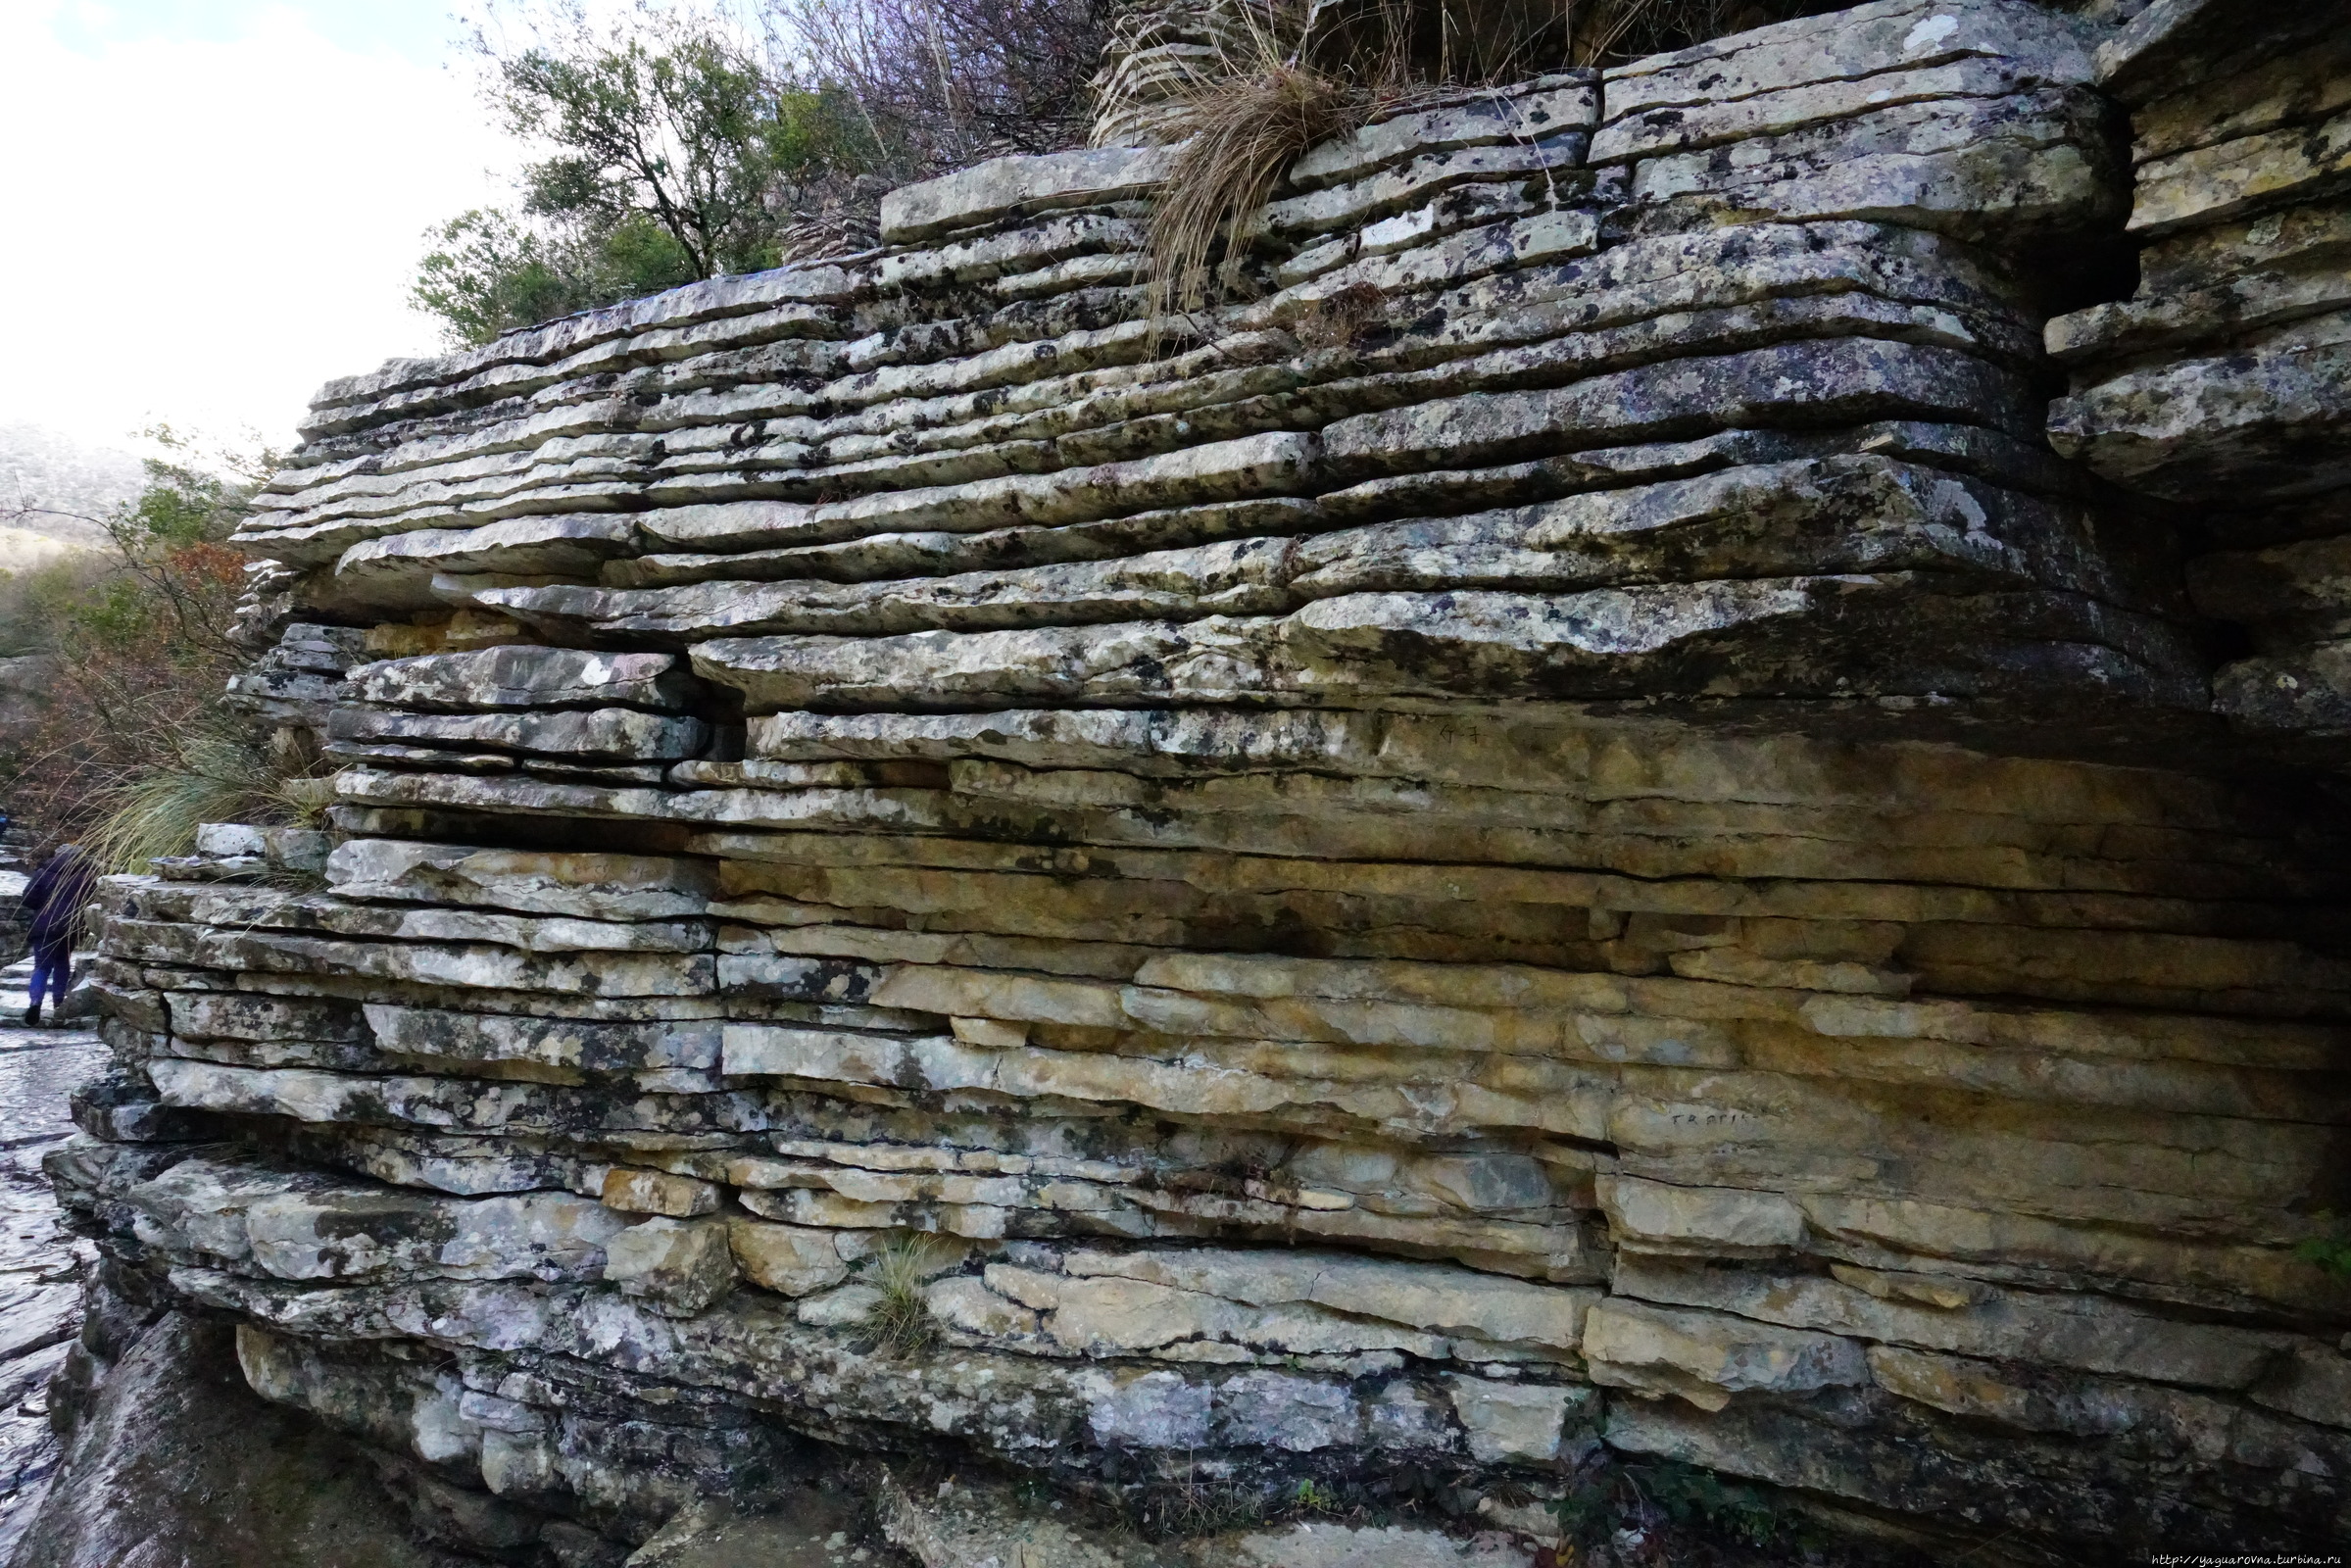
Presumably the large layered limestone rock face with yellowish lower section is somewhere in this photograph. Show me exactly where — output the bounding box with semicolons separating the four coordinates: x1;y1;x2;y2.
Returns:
31;0;2351;1563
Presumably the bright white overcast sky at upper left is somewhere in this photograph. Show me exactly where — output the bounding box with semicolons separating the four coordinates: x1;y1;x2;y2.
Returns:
0;0;513;444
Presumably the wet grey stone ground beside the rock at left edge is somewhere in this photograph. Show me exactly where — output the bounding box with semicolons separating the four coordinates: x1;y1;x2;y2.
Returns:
0;959;106;1561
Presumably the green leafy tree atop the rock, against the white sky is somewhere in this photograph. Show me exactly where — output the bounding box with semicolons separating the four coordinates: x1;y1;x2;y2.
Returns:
412;5;882;343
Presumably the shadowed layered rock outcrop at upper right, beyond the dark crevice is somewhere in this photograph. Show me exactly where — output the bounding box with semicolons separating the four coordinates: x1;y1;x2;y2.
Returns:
2048;0;2351;760
